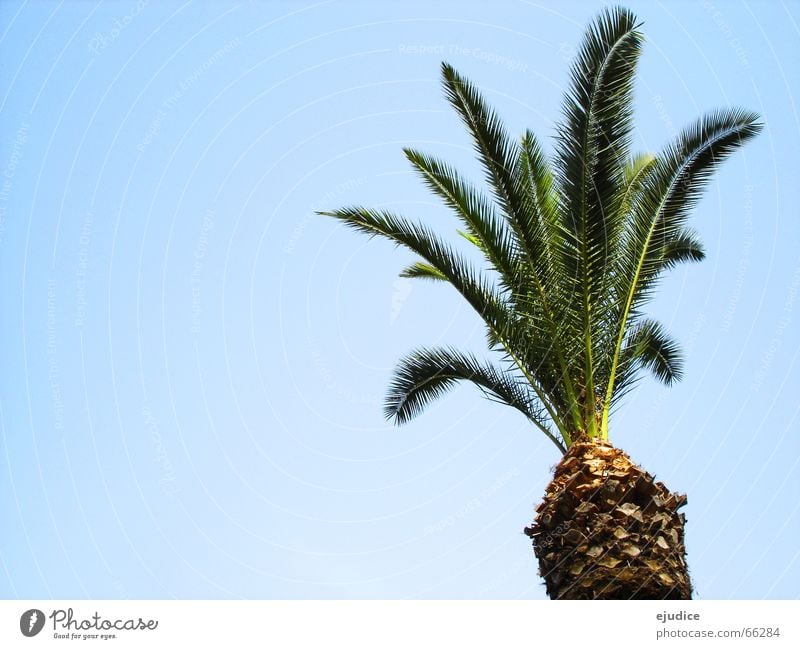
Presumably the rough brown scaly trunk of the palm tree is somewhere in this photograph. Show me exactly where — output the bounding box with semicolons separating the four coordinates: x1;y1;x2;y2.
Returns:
525;441;692;599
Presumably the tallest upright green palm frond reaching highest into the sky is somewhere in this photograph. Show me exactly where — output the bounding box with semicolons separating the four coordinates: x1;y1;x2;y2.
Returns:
556;8;642;435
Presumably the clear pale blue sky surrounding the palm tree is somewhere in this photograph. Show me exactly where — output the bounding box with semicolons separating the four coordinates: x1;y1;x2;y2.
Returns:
0;0;800;599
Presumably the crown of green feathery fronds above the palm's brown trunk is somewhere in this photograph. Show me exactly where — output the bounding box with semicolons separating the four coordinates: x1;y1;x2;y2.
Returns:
321;8;761;451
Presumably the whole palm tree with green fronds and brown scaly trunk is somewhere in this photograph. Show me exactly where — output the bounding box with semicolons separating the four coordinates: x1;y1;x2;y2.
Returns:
320;8;761;599
